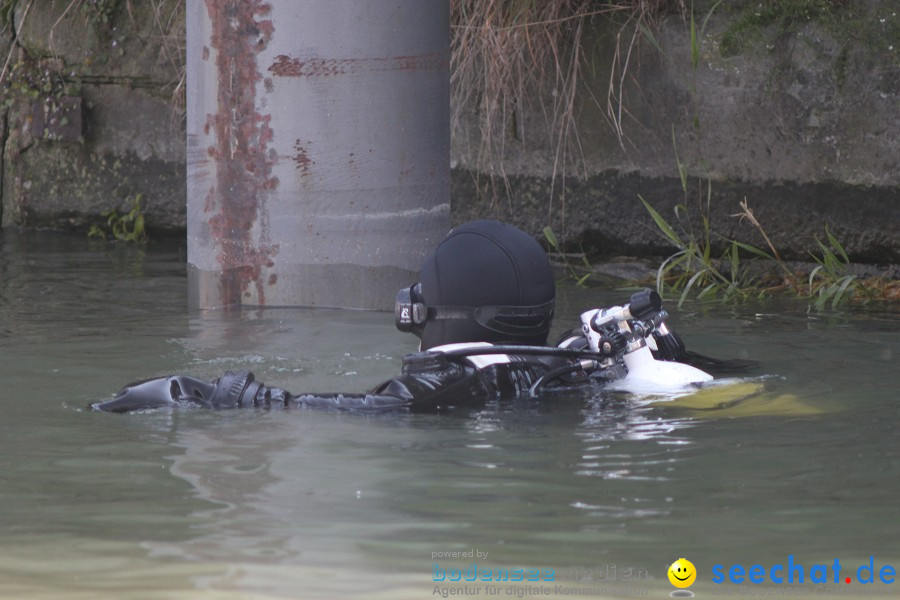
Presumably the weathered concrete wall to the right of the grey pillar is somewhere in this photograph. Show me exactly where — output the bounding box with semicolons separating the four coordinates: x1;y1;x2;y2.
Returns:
453;2;900;262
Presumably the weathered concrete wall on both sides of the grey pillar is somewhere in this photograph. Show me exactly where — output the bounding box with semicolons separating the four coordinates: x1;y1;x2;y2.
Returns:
0;0;900;262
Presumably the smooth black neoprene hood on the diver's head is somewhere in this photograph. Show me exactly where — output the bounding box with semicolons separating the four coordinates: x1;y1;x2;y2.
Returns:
419;221;556;350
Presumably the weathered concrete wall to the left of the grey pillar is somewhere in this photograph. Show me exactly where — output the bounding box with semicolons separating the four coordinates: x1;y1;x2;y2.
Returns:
0;0;185;229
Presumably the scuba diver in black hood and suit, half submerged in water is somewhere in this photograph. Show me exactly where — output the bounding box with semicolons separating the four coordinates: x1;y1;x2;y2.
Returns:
91;220;749;413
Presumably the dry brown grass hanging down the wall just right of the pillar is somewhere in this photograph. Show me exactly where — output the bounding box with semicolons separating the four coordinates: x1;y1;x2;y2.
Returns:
450;0;684;206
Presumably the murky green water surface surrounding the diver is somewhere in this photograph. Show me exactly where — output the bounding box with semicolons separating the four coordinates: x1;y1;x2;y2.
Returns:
0;232;900;599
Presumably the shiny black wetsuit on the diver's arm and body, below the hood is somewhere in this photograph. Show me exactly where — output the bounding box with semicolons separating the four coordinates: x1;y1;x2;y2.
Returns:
91;322;756;413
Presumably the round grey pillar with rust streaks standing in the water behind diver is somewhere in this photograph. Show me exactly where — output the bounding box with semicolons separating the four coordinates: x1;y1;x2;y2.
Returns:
187;0;450;309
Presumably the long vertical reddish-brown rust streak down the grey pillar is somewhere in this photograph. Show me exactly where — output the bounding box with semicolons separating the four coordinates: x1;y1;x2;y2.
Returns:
204;0;278;306
